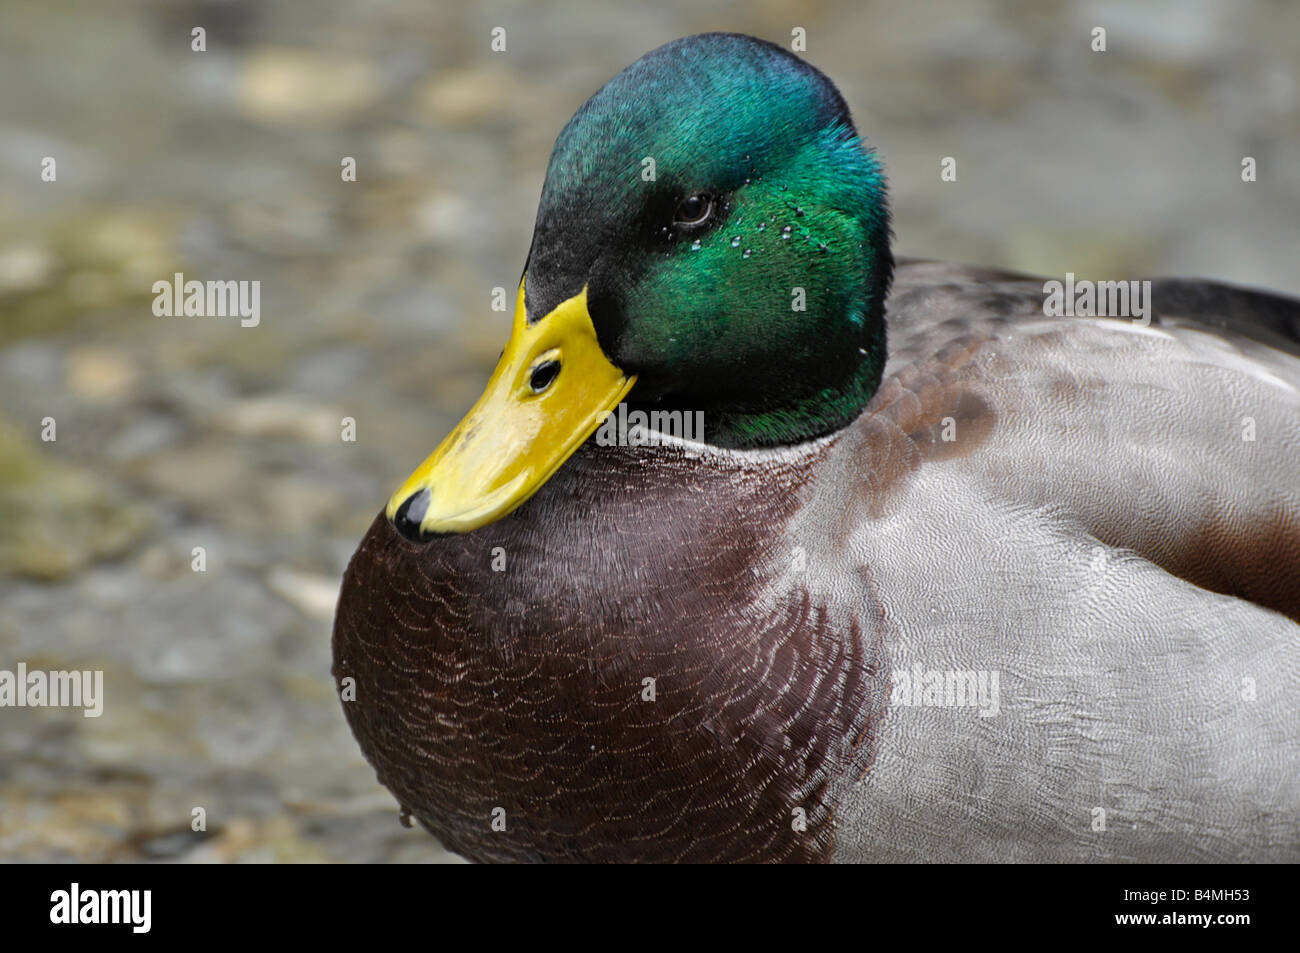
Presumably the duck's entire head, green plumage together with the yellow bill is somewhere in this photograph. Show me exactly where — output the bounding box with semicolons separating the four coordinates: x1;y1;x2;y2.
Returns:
387;34;893;538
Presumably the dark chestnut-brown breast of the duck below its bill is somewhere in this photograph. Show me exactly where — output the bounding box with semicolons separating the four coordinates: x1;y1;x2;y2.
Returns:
334;447;888;862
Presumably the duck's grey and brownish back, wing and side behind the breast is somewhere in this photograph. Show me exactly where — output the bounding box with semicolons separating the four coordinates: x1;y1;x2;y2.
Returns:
821;263;1300;861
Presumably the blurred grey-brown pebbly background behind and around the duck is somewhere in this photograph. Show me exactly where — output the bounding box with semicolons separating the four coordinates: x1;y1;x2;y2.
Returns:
0;0;1300;861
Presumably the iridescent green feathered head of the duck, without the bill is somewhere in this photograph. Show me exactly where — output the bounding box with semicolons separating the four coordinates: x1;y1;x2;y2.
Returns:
525;34;893;447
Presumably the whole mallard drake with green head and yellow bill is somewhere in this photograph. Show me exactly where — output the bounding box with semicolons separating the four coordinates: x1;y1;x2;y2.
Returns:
333;34;1300;861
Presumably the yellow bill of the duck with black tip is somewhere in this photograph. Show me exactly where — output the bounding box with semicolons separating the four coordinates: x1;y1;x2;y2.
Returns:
387;282;636;536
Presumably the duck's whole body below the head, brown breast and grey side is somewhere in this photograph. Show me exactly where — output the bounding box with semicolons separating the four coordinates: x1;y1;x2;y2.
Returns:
334;261;1300;862
